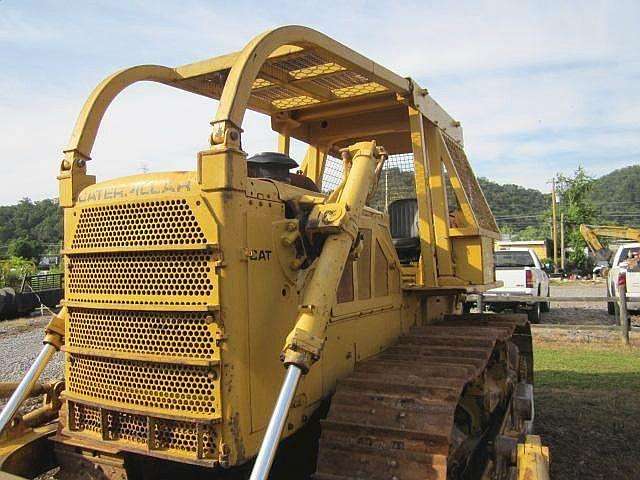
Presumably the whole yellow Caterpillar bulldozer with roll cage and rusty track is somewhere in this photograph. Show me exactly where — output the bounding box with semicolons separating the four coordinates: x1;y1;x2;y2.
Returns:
0;26;548;480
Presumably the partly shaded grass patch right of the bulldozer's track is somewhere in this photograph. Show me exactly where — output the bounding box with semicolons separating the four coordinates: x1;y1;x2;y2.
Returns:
535;343;640;480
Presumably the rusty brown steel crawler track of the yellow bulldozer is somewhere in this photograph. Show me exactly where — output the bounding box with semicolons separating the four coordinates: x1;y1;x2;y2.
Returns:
314;314;532;480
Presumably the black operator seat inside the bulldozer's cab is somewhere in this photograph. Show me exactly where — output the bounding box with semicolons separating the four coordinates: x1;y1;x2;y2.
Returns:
387;198;420;263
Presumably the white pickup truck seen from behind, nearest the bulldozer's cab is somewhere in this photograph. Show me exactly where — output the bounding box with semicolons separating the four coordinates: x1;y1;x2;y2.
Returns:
484;247;550;323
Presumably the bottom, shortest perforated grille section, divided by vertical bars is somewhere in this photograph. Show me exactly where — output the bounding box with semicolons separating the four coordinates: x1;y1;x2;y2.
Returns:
69;402;217;459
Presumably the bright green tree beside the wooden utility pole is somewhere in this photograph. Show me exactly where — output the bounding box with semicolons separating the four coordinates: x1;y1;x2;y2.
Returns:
556;167;598;273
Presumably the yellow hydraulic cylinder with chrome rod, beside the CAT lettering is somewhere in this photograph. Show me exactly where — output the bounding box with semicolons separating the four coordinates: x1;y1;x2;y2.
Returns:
251;142;385;480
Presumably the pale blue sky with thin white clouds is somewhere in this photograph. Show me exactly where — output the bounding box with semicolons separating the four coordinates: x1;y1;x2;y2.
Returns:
0;0;640;205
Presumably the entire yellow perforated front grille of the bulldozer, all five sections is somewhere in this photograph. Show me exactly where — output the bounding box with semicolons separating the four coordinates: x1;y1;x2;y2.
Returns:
64;177;221;466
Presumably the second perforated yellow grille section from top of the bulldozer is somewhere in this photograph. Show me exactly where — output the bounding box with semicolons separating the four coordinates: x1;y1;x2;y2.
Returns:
67;252;214;305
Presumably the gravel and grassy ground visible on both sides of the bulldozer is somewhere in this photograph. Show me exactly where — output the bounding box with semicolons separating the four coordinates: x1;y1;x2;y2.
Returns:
0;282;640;480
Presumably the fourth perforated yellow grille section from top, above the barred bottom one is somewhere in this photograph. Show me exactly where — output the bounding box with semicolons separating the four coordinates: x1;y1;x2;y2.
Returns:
67;354;218;418
